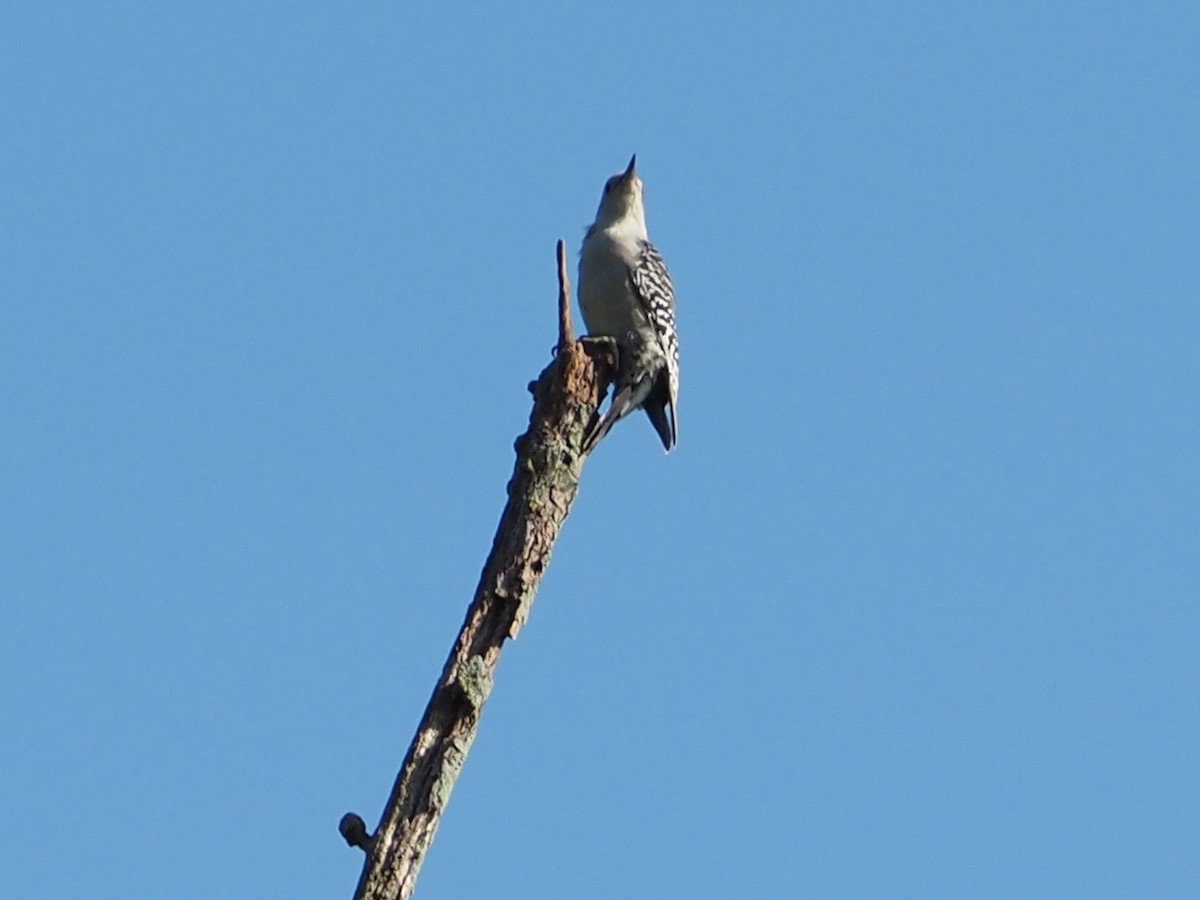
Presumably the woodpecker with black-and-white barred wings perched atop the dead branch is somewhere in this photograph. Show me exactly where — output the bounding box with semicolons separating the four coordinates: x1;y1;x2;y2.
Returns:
578;155;679;452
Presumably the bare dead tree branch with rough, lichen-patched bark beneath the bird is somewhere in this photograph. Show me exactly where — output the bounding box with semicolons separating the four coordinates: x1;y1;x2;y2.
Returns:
340;241;614;900
